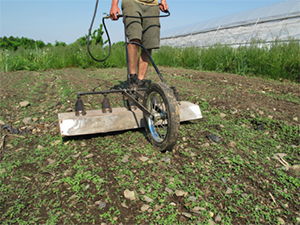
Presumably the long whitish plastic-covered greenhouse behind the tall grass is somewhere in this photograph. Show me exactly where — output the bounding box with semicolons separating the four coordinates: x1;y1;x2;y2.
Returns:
161;0;300;47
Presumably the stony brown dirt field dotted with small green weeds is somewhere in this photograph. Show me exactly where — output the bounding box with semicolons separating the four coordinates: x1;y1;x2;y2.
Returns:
0;67;300;224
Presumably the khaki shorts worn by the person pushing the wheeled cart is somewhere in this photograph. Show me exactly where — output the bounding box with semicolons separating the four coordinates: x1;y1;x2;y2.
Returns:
122;0;160;49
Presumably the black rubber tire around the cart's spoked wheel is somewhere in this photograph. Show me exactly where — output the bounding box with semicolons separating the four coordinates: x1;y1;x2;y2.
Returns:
143;83;180;151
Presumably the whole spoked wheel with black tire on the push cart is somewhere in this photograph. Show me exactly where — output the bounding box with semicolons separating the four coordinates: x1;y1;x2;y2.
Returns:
143;83;180;151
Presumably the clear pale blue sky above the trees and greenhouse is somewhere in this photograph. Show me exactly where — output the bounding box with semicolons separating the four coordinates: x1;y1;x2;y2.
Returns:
0;0;286;44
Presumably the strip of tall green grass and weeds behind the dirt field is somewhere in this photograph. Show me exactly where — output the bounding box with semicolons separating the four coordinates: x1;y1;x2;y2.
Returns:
0;40;300;82
